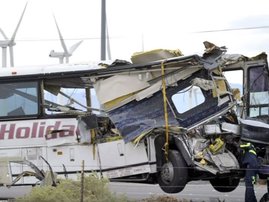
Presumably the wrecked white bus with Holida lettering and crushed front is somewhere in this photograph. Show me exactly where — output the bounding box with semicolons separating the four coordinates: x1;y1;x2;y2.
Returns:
0;42;268;193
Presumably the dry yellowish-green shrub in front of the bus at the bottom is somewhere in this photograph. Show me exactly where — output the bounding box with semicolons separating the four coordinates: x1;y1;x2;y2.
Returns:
16;175;127;202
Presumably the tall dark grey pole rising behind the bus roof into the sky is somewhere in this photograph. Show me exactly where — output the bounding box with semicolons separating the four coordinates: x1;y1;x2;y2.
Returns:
101;0;106;60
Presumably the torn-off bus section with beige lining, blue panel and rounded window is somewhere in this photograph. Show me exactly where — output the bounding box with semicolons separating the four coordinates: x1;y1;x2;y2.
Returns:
93;42;242;142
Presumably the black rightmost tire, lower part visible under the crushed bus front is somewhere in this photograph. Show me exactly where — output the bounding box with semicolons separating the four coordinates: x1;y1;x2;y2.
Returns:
210;177;240;192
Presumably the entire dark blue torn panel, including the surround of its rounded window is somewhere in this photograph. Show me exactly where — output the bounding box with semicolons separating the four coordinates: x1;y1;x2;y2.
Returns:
108;72;231;142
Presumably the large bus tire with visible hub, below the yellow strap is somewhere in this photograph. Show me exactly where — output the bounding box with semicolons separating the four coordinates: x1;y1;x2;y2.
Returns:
158;150;188;193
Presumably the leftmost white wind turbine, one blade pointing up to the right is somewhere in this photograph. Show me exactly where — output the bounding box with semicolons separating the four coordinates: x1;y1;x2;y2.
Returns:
0;3;27;67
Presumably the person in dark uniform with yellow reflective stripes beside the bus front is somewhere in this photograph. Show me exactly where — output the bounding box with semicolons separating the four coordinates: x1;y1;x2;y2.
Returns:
240;142;259;202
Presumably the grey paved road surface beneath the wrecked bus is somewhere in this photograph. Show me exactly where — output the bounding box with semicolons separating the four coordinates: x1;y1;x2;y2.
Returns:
0;181;266;202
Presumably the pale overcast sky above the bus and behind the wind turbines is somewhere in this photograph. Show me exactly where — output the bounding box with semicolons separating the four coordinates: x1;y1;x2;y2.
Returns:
0;0;269;66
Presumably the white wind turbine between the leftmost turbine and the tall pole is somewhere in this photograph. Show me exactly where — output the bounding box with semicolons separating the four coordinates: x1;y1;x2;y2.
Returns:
49;16;82;64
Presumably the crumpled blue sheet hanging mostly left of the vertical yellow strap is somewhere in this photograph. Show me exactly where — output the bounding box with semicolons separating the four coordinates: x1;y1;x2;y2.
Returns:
109;92;178;142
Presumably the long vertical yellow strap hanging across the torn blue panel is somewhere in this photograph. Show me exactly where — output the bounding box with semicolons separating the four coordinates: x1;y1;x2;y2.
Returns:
161;61;169;160
